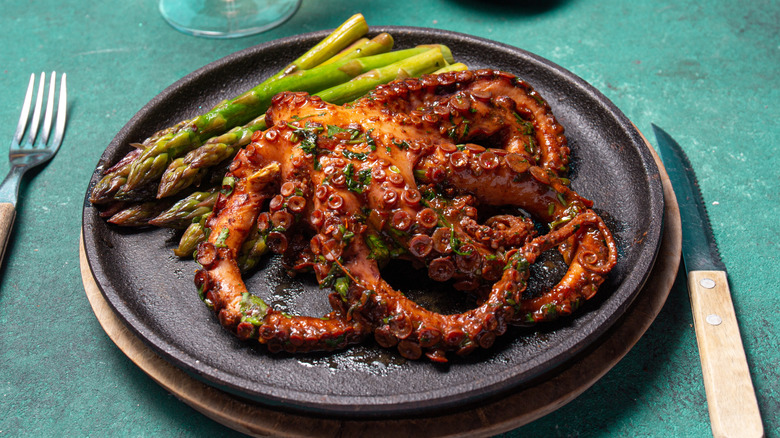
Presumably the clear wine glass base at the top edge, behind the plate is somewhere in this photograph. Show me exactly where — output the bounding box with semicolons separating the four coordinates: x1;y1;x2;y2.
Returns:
159;0;302;38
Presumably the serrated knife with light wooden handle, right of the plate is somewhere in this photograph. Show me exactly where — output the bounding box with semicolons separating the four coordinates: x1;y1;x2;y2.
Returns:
653;125;764;437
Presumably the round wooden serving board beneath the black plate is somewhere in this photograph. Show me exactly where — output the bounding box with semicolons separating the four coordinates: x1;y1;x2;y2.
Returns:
80;140;682;438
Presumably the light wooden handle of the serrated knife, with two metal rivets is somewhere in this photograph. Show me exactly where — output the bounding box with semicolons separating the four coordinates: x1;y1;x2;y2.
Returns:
688;271;764;438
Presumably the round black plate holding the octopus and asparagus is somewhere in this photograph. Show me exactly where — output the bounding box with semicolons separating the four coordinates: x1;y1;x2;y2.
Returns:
83;27;663;418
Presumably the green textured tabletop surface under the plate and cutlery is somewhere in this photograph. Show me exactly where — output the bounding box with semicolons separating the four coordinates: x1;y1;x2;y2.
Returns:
0;0;780;438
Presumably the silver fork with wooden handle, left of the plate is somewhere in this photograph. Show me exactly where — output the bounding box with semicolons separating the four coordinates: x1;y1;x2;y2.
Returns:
0;72;68;265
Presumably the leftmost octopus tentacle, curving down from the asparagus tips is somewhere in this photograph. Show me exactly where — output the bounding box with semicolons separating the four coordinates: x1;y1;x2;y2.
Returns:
195;159;367;352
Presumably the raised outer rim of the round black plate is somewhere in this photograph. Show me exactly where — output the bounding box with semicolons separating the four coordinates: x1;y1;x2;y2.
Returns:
82;26;664;417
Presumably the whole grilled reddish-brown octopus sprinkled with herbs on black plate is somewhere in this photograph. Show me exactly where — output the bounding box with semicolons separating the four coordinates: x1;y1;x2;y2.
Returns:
195;70;617;362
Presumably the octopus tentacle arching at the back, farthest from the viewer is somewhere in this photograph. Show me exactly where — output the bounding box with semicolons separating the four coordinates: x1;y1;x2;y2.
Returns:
361;70;570;173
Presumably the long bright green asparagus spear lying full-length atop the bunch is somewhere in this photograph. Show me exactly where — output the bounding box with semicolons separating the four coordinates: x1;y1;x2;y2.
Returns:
119;47;427;200
